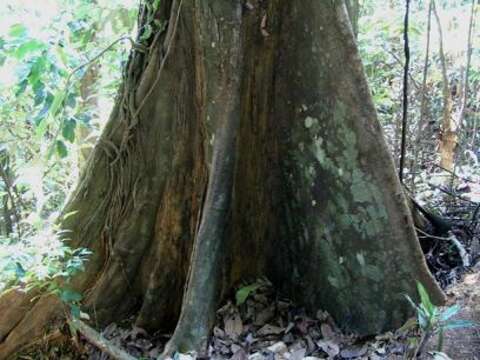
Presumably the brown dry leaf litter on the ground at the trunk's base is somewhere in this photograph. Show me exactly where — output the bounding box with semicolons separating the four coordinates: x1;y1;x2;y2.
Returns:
18;264;480;360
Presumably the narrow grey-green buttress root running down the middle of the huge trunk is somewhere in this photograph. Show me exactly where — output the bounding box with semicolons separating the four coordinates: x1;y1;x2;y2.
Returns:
163;0;243;357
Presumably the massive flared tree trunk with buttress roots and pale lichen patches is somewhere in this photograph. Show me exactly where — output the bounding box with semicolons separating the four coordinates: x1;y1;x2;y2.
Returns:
0;0;443;358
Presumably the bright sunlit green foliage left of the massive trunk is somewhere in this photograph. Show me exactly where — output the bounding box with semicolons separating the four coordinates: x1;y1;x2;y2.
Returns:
0;0;137;290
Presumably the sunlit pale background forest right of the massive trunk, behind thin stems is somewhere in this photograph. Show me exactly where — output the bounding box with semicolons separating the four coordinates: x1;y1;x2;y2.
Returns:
359;0;479;204
